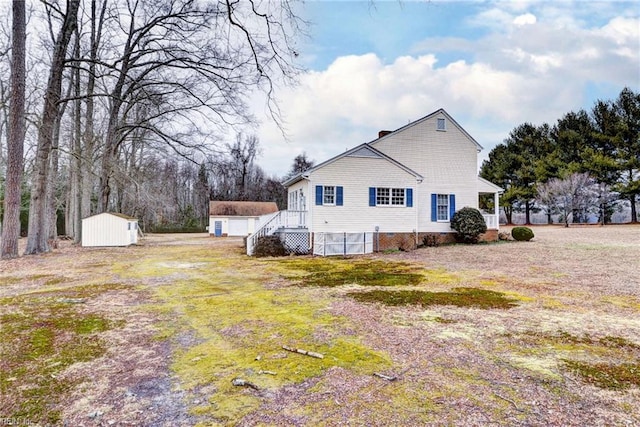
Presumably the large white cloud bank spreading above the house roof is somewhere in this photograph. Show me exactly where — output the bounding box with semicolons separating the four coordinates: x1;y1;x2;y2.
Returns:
252;7;640;175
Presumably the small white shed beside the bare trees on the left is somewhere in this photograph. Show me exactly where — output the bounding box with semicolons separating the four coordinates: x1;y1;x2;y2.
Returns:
82;212;138;247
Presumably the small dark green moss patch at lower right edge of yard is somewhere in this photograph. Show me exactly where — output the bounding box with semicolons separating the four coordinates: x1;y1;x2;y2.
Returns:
564;360;640;390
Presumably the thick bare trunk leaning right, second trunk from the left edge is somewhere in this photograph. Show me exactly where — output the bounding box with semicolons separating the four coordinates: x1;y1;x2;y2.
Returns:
25;0;80;255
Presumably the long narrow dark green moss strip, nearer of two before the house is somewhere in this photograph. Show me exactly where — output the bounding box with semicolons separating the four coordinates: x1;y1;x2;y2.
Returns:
347;288;517;309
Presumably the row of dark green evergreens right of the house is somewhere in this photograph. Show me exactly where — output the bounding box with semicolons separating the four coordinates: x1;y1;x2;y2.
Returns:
480;87;640;225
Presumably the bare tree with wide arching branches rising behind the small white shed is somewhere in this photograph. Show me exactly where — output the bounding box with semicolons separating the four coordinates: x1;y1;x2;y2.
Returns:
92;0;299;211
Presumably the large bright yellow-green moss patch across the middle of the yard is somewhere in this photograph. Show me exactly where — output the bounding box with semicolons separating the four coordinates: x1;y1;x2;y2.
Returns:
142;248;392;425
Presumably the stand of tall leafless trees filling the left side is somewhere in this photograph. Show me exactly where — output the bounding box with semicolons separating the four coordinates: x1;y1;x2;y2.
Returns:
0;0;306;258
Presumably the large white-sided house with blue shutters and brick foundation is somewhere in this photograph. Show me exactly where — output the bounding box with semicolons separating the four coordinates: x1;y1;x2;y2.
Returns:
247;109;502;255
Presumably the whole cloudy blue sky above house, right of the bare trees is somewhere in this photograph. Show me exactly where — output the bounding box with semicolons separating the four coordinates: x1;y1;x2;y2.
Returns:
248;0;640;176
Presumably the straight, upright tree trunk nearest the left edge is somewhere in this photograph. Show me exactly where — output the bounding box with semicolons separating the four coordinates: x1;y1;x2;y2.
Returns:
0;0;27;259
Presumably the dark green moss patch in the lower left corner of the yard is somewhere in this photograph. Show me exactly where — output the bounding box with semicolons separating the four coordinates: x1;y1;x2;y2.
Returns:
0;289;118;425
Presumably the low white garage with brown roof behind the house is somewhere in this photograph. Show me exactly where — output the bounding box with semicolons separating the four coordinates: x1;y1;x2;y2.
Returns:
209;201;278;237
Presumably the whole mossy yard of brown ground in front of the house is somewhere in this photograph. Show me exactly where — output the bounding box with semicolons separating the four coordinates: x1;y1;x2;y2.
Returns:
0;226;640;426
